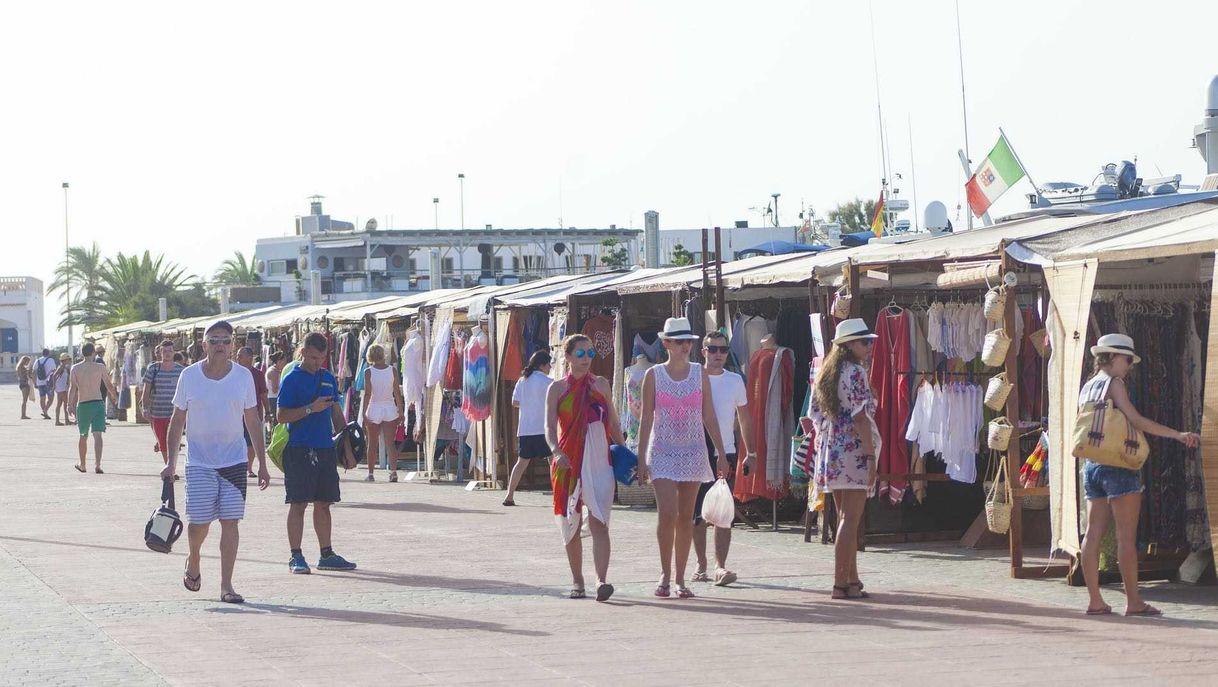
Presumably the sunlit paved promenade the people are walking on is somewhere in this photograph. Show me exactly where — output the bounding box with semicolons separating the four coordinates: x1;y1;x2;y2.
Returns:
0;386;1218;687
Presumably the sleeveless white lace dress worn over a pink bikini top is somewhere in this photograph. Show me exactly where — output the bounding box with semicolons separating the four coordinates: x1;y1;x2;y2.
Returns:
647;363;715;482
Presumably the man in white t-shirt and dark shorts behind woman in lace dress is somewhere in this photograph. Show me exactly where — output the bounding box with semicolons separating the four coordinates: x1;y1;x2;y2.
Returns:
693;331;756;587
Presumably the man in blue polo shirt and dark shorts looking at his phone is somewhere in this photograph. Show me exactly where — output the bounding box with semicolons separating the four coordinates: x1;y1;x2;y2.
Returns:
278;333;356;575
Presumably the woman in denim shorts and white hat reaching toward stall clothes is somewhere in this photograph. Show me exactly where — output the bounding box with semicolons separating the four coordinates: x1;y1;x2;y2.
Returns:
1079;334;1201;615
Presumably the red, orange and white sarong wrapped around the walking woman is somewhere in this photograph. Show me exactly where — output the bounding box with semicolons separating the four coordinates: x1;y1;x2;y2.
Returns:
549;374;614;542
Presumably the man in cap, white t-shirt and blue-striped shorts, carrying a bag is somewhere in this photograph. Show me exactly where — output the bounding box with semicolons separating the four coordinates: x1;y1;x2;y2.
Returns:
161;320;270;603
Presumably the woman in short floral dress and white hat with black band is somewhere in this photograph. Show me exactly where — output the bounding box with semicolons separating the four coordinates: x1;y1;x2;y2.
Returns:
808;319;881;599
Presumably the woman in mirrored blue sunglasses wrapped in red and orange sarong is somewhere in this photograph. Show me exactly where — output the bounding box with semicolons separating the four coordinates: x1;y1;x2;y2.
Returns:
546;334;628;602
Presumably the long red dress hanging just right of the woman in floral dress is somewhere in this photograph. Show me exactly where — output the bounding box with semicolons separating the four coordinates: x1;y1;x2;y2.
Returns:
871;308;918;504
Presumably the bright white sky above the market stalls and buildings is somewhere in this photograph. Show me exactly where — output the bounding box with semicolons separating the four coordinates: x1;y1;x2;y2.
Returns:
0;0;1218;341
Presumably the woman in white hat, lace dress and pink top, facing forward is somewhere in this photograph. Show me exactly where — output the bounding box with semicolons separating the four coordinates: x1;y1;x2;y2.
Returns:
638;317;727;599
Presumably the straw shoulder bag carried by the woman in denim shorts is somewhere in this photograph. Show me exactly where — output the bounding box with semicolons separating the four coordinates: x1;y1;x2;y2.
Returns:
1072;379;1150;470
